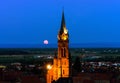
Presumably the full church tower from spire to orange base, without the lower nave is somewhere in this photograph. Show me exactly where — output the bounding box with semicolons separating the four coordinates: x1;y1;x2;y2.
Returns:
58;12;70;77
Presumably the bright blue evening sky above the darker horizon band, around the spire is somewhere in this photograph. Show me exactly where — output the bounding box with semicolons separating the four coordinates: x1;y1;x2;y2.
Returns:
0;0;120;44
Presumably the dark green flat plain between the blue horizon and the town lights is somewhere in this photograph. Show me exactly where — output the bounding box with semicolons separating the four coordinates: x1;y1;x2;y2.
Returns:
0;48;120;64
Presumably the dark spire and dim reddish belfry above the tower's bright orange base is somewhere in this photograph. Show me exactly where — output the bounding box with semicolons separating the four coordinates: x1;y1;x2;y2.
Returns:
58;11;69;58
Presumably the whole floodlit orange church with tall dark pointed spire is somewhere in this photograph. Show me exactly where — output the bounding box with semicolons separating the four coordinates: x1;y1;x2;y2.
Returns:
46;12;71;83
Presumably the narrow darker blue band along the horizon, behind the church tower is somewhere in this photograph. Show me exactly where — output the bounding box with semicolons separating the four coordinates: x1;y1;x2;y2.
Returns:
0;42;120;48
